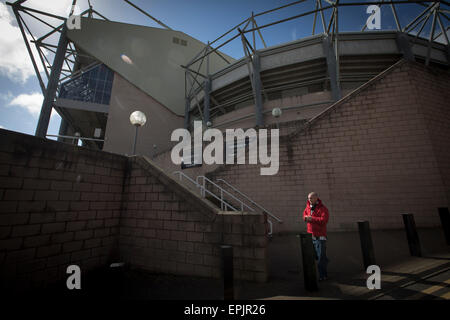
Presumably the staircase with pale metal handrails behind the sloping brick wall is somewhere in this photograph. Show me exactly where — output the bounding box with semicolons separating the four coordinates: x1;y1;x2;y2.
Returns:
173;171;283;236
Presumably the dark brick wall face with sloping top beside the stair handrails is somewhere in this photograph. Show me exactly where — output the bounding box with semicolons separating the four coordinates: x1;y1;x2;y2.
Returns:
120;159;268;281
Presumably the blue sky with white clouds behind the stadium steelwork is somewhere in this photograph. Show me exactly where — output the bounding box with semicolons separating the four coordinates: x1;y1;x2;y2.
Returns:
0;0;448;139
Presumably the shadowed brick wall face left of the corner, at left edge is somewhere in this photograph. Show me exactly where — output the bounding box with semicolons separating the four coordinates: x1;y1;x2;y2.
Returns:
0;130;126;291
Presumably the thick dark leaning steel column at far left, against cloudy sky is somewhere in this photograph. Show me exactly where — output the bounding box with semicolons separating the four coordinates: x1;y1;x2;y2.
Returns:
35;25;69;138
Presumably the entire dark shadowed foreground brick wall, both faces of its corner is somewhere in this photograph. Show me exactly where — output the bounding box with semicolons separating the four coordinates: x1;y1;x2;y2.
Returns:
0;130;267;292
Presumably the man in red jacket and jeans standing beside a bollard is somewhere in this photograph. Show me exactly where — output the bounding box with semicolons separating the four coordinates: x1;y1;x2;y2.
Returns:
303;192;329;281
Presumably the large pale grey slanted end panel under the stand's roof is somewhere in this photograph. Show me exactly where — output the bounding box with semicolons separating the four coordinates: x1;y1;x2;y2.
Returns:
67;18;234;115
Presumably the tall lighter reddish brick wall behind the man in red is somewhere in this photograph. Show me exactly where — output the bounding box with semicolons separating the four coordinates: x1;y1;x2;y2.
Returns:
210;62;450;232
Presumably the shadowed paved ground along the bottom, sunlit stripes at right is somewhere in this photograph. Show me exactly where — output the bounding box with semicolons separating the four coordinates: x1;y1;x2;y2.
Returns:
102;248;450;300
